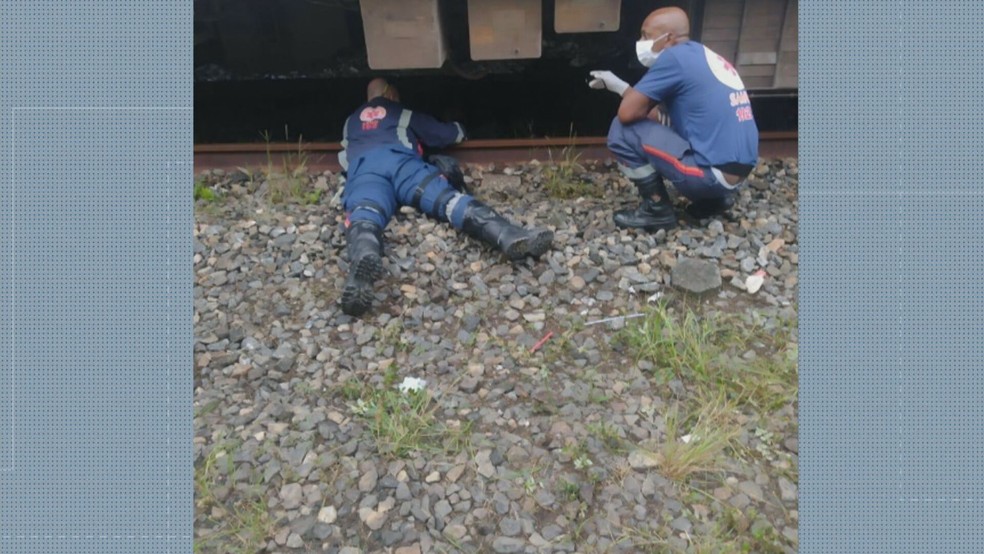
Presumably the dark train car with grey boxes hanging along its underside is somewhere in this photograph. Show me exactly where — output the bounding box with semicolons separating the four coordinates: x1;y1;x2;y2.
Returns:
195;0;797;145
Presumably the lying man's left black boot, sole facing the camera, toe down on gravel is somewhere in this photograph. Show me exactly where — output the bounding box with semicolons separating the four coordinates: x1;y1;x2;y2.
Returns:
342;221;383;317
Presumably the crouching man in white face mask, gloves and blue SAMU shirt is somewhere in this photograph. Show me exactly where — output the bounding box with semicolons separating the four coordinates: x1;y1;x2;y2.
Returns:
588;8;759;231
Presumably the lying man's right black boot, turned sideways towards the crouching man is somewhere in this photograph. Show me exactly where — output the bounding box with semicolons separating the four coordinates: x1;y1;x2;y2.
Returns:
463;200;553;260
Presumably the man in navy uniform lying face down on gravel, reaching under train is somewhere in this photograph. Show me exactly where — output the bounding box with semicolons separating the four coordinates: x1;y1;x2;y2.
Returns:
338;79;553;316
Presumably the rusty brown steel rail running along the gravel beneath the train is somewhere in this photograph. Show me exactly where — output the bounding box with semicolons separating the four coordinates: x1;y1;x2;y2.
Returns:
194;131;797;172
